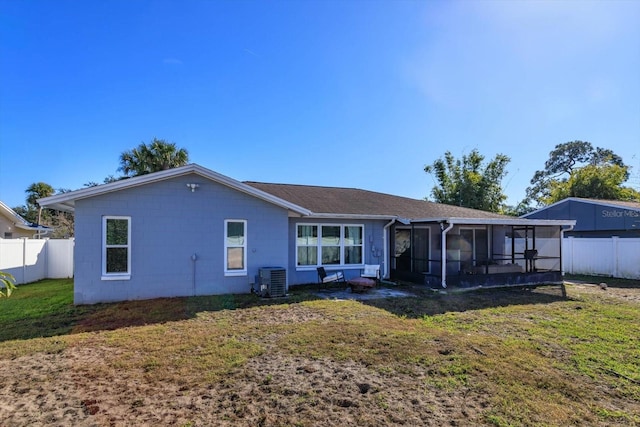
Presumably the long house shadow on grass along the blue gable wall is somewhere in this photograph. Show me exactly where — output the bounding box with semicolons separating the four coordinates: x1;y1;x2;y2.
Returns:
0;285;318;342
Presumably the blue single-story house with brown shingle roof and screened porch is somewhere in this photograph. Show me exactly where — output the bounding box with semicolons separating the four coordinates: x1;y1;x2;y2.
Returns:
39;164;574;304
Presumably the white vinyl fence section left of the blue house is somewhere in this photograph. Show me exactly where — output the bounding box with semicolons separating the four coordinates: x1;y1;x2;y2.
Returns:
0;239;74;284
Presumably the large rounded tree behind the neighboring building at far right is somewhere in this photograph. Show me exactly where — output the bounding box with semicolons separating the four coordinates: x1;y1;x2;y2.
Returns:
524;141;633;206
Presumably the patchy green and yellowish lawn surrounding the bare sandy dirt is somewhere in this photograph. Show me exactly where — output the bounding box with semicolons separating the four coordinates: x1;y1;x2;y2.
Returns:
0;278;640;426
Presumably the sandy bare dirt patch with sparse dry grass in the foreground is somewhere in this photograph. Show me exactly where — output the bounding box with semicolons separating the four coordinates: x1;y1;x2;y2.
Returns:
0;348;488;426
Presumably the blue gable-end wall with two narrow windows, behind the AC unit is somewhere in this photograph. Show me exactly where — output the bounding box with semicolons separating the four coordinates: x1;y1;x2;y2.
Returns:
74;175;288;304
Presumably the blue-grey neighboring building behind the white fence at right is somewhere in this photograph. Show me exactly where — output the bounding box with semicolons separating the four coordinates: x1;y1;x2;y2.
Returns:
523;197;640;237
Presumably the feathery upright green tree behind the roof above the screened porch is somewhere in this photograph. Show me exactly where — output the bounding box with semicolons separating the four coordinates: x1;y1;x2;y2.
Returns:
424;149;510;212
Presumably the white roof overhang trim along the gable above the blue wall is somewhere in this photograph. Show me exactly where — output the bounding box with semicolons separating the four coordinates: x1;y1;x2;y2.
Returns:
38;164;311;216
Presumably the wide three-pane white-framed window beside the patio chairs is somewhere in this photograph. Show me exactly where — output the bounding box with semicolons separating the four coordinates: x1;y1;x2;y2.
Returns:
296;224;364;267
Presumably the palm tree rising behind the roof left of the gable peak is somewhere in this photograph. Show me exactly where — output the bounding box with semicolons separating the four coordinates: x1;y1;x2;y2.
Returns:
118;138;189;177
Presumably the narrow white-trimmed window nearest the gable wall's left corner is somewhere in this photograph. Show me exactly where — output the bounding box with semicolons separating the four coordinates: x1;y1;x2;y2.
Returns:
102;216;131;280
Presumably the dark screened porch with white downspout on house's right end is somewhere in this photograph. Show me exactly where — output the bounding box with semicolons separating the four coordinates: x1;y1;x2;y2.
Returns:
390;219;572;287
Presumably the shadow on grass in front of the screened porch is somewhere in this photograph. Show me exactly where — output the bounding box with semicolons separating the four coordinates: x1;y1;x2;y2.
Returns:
362;285;567;318
